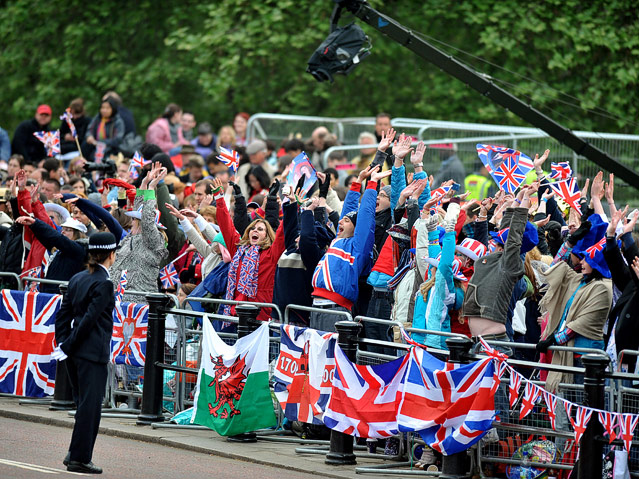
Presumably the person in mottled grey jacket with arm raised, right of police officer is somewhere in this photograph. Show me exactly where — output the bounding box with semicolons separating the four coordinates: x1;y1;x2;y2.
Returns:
110;163;169;304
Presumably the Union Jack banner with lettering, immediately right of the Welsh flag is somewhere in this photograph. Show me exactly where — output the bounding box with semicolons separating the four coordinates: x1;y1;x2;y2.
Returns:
273;325;336;424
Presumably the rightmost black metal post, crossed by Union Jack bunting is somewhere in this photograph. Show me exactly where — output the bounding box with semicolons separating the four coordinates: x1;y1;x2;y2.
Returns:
577;354;608;479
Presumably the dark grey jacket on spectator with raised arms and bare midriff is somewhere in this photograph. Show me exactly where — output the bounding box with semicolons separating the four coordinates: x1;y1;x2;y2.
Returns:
462;208;528;324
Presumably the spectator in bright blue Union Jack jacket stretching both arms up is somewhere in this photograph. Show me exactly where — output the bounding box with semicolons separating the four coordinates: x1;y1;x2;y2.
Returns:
310;166;391;331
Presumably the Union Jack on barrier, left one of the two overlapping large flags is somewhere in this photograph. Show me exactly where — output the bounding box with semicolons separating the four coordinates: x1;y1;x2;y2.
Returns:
323;345;410;438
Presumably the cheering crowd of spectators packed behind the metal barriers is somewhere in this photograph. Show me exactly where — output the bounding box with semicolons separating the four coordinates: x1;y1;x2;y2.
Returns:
0;100;639;389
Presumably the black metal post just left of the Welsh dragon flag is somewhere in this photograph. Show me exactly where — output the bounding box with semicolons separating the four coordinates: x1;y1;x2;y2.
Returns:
137;293;170;426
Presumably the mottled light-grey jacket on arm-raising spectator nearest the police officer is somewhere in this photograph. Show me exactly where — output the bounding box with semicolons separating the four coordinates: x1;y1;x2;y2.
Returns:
109;196;169;304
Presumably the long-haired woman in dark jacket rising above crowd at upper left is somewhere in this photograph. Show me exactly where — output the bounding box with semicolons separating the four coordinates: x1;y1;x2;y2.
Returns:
82;97;124;158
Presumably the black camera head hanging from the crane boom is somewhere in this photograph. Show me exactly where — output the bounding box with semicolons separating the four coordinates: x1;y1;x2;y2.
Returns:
306;23;370;83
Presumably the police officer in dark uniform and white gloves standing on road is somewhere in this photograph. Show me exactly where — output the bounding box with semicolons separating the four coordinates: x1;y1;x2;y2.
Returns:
51;232;116;474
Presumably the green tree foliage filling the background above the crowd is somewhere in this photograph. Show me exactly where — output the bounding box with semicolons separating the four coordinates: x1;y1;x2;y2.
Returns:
0;0;639;133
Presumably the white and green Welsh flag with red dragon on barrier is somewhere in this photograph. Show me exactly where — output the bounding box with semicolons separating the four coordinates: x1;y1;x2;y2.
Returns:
191;318;277;436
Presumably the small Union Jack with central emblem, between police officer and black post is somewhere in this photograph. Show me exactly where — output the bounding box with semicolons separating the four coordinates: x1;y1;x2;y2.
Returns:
111;302;149;367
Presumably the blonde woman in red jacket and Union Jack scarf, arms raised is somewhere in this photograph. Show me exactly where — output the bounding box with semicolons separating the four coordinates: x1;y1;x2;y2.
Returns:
213;179;284;321
